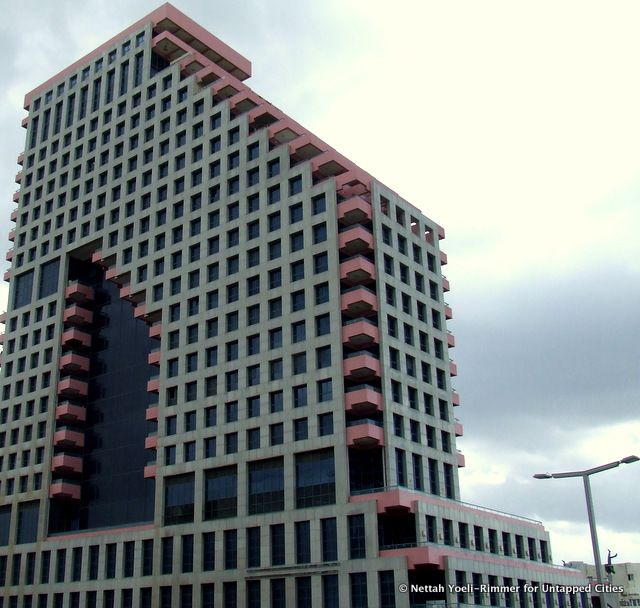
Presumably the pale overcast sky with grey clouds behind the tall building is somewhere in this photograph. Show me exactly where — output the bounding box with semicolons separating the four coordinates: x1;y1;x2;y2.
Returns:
0;0;640;562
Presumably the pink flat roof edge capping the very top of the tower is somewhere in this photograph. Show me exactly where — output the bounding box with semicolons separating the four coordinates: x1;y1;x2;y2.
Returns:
24;3;251;109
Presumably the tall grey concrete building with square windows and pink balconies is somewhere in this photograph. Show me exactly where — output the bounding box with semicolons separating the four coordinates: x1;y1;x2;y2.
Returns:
0;4;584;608
